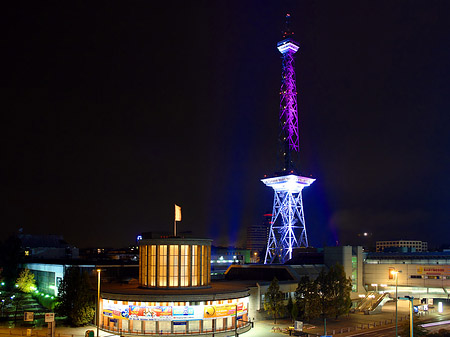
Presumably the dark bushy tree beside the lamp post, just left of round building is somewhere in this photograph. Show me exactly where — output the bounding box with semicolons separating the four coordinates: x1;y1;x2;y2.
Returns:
55;267;95;326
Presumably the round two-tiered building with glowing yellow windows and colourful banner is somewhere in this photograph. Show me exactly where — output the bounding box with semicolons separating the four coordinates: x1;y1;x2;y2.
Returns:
100;237;251;336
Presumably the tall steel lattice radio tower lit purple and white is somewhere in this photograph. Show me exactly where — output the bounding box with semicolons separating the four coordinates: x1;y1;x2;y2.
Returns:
261;14;315;264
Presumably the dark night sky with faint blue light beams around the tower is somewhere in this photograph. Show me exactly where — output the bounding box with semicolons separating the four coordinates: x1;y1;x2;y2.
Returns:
1;0;450;247
